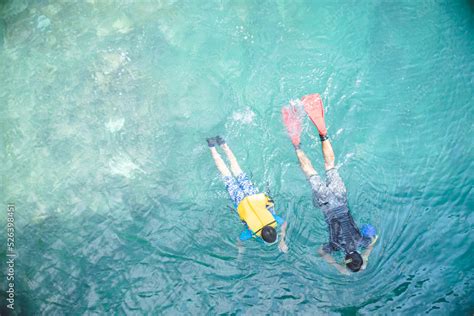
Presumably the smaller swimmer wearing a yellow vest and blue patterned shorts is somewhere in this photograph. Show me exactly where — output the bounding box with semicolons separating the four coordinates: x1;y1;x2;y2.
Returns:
207;136;288;252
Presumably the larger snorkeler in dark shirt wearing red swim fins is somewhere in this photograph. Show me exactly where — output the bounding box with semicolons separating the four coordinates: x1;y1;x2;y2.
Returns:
282;94;378;275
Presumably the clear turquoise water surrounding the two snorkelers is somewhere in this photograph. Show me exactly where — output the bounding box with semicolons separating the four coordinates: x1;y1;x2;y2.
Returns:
0;1;474;315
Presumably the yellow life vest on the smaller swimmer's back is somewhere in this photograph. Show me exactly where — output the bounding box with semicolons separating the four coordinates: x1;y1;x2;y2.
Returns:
237;193;277;237
